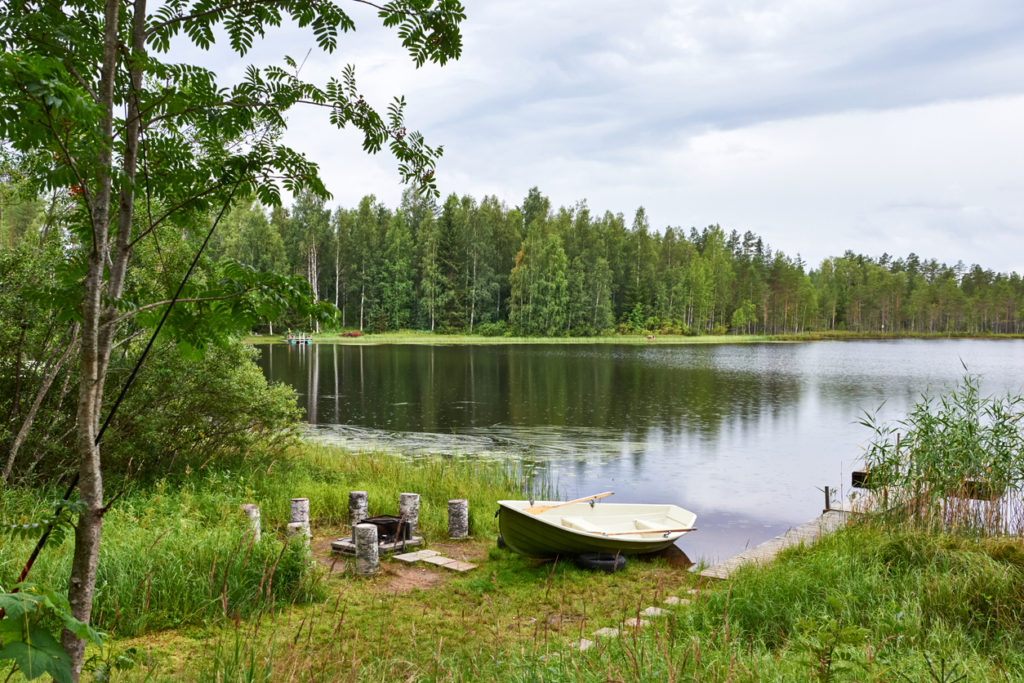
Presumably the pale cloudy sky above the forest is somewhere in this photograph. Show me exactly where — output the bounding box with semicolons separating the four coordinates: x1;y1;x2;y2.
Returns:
195;0;1024;273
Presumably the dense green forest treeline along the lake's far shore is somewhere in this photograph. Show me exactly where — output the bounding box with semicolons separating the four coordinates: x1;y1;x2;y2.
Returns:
0;179;1024;336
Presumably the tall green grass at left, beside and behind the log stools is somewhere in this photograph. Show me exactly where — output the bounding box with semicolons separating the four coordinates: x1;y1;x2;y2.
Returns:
0;445;535;637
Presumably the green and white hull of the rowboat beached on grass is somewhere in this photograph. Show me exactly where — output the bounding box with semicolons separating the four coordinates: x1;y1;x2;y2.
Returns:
498;501;696;557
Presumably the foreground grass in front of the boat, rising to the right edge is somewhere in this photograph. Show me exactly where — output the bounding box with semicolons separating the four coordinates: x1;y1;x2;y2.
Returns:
120;507;1024;681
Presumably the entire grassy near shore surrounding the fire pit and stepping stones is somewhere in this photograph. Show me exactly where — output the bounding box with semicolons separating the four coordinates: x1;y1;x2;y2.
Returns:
8;445;1024;681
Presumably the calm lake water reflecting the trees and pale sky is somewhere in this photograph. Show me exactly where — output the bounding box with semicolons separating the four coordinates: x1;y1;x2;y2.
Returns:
259;340;1024;561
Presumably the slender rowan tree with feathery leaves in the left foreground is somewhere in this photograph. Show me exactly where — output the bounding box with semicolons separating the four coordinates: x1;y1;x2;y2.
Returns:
0;0;465;679
